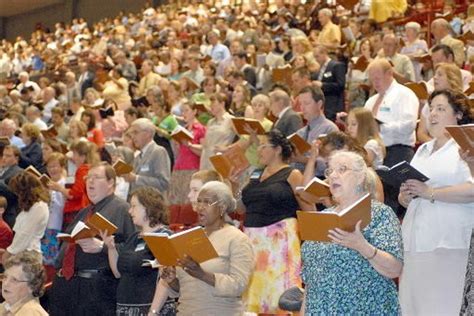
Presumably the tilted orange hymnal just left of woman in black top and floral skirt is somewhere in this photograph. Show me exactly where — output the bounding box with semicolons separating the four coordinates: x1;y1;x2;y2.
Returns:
209;145;250;178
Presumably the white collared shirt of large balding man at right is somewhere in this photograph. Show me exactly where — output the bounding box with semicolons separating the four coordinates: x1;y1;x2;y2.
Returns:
365;80;419;147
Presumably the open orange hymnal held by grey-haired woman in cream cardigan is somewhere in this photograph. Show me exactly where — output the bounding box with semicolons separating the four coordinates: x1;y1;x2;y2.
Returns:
143;226;218;266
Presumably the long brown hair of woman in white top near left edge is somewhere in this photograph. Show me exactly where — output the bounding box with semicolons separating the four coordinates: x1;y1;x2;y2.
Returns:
9;171;49;212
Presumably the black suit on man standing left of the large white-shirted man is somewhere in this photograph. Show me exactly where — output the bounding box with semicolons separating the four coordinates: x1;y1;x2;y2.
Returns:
311;60;346;121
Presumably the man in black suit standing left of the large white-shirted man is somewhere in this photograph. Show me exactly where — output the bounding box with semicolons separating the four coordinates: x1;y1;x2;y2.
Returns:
311;46;346;121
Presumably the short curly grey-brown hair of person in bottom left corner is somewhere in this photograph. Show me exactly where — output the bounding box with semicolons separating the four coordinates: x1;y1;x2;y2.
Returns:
4;250;46;297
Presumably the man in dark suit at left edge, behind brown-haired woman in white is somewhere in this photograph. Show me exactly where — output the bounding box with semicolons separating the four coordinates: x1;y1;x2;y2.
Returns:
0;145;23;227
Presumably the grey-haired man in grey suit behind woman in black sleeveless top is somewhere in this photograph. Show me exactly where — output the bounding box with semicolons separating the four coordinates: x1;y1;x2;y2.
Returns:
269;89;303;136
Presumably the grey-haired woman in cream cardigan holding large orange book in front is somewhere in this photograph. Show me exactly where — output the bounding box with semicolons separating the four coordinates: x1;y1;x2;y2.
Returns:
149;181;254;315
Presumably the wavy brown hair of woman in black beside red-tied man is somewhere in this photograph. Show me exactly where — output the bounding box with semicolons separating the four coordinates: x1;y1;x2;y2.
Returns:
131;187;169;227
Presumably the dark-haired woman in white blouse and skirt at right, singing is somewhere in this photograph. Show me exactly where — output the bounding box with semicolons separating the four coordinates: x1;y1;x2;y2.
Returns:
399;90;474;315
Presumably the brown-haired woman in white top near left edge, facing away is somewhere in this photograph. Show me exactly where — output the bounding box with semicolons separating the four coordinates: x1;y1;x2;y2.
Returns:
2;171;49;262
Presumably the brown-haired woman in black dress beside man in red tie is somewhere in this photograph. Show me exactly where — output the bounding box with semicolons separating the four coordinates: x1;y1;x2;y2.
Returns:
101;187;176;316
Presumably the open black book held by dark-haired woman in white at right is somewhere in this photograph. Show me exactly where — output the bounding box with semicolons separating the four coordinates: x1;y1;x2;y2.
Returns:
377;161;429;188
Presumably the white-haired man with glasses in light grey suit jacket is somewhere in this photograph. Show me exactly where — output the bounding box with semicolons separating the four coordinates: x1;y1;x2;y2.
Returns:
123;118;171;192
